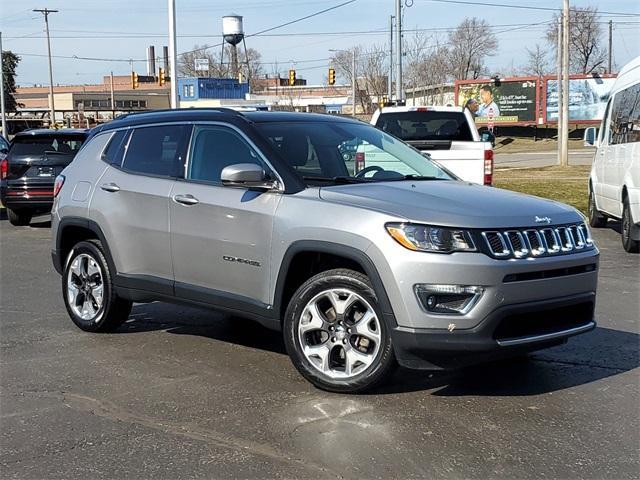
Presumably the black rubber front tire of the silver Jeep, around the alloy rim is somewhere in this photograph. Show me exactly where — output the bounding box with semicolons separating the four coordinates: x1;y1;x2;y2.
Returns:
283;269;396;393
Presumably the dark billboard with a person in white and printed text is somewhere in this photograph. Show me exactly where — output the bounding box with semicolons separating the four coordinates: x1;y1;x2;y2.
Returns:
456;77;538;125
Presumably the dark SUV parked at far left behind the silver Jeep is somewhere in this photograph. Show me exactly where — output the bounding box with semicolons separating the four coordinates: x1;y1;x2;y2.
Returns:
0;129;88;225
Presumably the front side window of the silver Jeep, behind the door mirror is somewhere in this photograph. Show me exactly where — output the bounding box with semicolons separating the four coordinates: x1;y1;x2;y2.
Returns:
187;126;264;182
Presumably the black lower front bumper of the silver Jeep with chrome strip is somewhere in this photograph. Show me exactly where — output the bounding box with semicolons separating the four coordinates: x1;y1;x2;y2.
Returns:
391;293;596;369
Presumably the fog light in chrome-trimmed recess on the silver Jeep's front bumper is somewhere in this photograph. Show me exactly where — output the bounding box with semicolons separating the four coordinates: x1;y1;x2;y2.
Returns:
414;284;484;315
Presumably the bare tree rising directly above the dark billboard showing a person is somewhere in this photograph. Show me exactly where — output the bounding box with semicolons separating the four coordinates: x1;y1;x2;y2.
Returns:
449;17;498;80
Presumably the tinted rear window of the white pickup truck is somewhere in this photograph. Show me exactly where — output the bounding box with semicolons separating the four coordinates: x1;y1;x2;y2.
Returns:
376;111;473;142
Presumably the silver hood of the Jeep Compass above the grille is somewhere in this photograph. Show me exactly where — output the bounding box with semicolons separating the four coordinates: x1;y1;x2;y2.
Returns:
320;180;584;229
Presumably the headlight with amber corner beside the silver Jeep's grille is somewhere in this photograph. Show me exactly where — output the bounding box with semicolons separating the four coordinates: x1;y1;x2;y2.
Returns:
385;223;476;253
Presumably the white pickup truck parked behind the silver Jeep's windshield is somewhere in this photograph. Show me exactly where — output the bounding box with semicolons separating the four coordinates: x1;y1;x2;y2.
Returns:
370;107;493;185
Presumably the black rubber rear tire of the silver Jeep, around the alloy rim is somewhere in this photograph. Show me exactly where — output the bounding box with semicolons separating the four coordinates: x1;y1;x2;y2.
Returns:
62;240;132;332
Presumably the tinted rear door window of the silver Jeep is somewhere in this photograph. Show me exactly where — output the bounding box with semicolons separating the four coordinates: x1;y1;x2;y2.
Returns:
123;125;191;177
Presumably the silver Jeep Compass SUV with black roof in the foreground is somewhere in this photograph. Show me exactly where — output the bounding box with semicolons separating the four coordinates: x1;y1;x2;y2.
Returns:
52;109;598;392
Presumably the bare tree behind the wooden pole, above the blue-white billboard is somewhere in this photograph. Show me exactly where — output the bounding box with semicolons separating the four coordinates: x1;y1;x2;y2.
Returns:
547;7;606;73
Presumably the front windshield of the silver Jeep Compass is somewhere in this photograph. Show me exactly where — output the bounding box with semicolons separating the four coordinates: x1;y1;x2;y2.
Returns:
256;122;455;182
